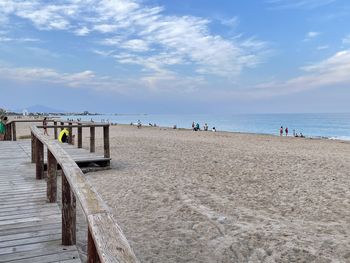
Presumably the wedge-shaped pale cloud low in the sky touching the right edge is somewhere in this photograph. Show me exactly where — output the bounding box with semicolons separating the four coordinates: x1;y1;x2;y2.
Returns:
248;50;350;96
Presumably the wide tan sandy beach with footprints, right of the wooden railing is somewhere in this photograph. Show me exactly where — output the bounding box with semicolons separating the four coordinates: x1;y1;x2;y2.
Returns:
15;122;350;263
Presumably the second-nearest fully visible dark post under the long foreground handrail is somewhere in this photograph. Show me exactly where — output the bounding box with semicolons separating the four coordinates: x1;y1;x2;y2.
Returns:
46;149;57;203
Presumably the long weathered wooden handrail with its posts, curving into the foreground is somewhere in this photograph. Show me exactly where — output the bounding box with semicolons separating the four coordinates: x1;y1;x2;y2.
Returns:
31;125;139;263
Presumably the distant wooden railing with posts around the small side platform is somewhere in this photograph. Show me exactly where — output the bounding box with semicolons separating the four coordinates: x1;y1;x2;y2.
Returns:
5;119;110;158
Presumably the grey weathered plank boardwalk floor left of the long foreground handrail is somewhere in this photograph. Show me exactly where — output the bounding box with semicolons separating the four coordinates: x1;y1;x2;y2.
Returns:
0;141;81;263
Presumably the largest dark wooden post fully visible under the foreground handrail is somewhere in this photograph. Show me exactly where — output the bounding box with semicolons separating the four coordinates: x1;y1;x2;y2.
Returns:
62;172;76;246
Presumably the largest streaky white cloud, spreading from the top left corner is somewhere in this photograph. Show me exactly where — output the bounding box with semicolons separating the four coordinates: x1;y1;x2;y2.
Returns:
0;0;267;82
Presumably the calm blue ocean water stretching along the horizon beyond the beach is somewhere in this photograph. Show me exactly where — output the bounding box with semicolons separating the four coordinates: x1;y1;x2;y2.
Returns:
62;113;350;140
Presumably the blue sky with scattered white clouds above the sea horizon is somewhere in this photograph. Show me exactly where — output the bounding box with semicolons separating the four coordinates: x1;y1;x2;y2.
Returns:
0;0;350;114
